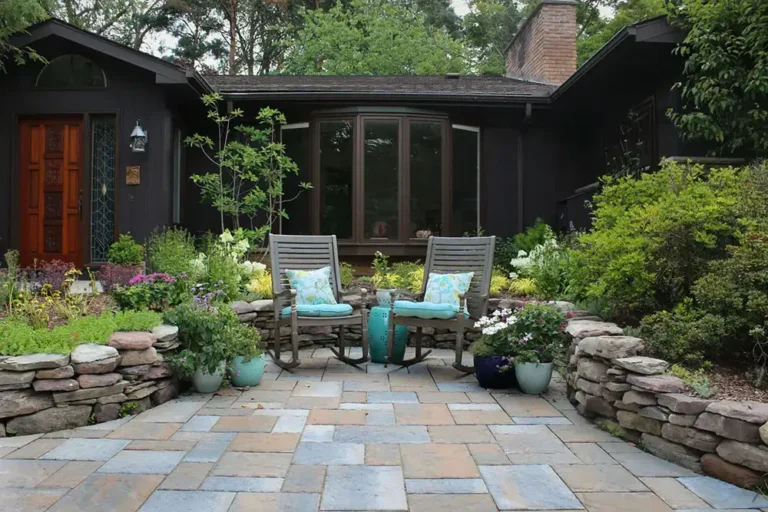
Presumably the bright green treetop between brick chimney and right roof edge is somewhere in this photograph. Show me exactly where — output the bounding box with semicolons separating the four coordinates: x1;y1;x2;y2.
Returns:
576;0;666;66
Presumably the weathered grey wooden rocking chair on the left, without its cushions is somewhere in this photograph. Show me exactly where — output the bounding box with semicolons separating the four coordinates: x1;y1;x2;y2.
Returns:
269;234;369;370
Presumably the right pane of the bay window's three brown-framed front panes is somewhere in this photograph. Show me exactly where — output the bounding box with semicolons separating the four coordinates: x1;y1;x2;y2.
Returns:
410;122;443;238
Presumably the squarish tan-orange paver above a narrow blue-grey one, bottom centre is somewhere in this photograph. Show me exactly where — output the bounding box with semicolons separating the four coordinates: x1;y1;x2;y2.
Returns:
400;444;480;478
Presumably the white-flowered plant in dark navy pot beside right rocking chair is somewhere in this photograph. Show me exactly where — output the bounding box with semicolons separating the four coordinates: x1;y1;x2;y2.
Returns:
470;309;517;389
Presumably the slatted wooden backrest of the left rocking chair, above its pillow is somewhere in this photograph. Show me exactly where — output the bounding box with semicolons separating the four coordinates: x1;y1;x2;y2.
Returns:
269;233;341;301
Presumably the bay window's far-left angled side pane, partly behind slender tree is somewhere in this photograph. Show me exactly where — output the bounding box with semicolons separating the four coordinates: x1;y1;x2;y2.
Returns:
281;128;312;235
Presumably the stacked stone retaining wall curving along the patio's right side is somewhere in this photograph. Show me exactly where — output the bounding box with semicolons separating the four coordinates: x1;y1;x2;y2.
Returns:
566;319;768;487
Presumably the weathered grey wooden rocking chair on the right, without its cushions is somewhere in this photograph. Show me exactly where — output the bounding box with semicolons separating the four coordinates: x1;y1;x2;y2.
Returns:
387;236;496;373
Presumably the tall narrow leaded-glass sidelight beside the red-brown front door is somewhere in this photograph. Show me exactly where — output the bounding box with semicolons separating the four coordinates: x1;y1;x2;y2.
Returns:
91;116;116;263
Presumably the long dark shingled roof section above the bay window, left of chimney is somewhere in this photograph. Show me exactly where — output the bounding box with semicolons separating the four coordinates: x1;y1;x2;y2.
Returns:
205;75;555;101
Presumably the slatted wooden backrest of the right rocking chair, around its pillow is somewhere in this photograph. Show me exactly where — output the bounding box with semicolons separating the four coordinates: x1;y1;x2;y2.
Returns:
421;236;496;319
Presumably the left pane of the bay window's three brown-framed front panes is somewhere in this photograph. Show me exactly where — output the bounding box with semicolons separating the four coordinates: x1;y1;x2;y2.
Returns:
318;121;354;238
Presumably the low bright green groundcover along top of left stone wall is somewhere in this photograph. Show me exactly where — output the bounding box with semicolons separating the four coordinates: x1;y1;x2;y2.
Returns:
0;311;161;356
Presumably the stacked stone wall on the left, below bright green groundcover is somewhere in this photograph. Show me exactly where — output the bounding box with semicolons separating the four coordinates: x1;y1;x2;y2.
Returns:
0;326;178;437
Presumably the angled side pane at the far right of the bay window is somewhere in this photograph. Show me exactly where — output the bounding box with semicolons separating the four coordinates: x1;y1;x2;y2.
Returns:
452;128;480;236
